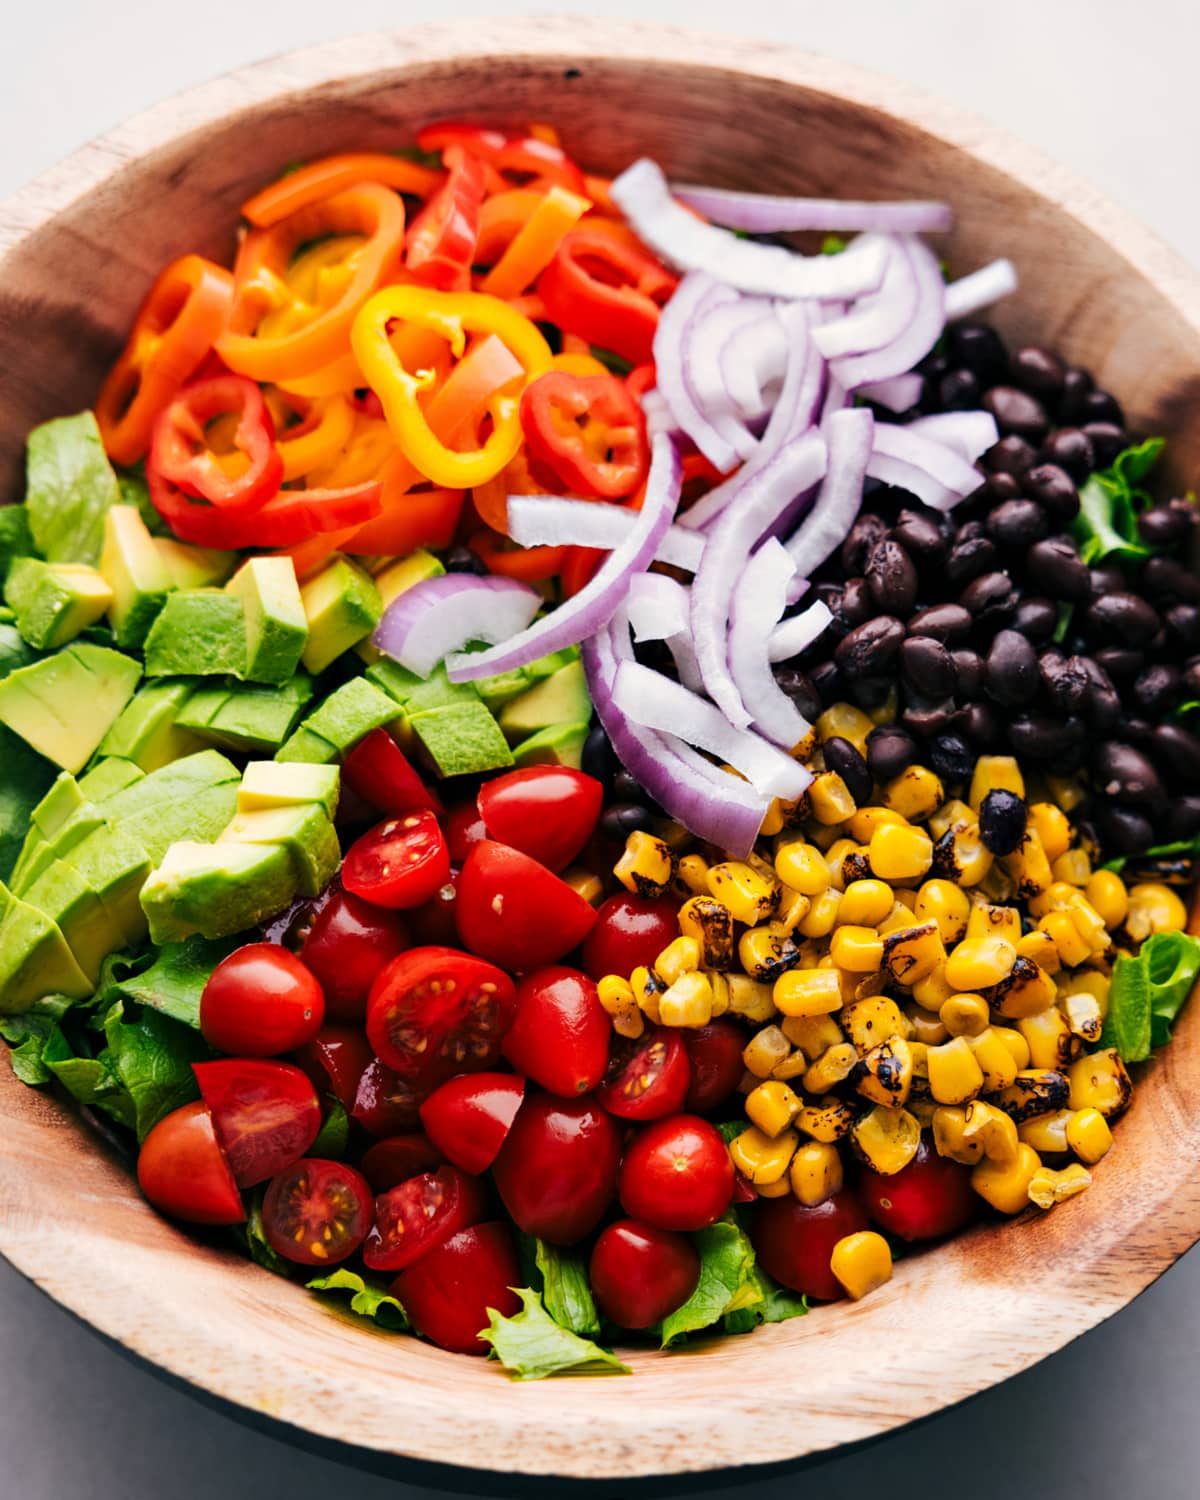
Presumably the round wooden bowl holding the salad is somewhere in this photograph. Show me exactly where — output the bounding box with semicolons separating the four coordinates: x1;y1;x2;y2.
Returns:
0;17;1200;1479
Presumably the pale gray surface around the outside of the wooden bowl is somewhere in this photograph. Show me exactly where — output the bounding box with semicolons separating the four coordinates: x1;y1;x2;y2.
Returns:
0;0;1200;1500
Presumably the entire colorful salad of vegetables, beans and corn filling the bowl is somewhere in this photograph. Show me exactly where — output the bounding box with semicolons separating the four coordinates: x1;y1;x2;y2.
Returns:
0;123;1200;1379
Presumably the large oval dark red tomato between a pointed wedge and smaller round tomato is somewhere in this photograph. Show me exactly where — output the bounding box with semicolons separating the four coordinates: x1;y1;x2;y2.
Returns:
492;1094;621;1245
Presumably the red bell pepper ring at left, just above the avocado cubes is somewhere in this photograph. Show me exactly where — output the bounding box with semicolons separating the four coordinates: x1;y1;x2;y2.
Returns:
147;375;284;515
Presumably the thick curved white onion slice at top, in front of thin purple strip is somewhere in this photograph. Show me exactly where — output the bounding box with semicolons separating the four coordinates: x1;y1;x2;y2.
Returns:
612;158;884;306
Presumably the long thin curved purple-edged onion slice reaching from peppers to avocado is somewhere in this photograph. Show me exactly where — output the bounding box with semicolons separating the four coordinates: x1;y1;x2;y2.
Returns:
446;435;683;683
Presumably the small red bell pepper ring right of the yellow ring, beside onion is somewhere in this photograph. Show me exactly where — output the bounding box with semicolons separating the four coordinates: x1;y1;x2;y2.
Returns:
521;371;650;500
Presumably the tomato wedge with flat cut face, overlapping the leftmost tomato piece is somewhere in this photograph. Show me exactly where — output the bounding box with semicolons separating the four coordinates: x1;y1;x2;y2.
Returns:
192;1058;321;1188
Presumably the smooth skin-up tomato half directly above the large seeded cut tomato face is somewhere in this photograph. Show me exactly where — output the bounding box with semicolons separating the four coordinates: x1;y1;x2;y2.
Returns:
458;839;596;974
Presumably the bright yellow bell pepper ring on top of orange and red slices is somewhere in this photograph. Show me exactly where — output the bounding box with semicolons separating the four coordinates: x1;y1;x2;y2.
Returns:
351;287;554;489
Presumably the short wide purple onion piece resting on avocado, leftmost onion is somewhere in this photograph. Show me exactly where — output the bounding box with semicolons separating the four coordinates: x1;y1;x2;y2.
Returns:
371;573;545;677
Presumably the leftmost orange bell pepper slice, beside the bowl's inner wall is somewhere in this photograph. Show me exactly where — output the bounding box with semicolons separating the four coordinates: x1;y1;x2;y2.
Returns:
96;255;234;465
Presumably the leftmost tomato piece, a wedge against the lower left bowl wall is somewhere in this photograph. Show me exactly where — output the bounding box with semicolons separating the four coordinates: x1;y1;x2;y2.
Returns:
138;1100;246;1224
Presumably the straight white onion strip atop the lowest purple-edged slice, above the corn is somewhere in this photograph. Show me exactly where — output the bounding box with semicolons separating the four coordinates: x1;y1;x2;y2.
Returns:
612;662;813;803
